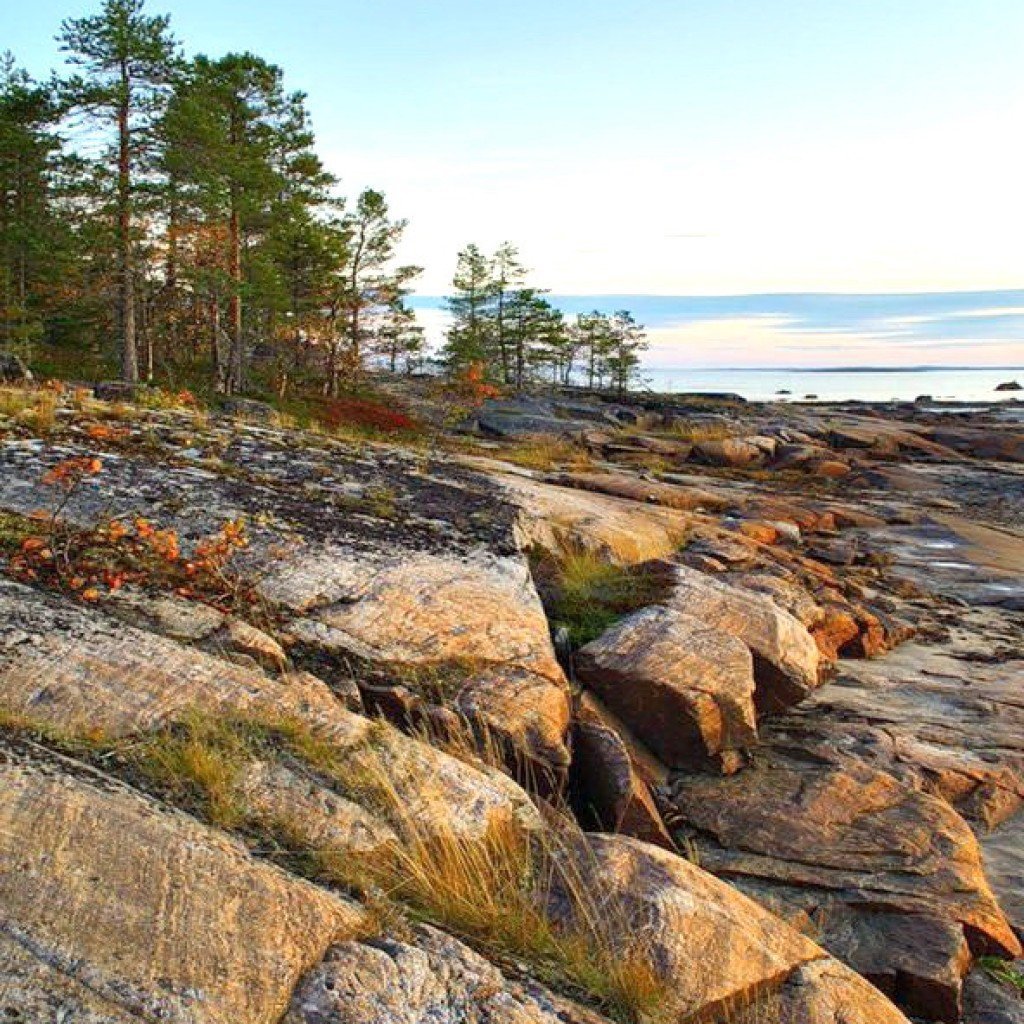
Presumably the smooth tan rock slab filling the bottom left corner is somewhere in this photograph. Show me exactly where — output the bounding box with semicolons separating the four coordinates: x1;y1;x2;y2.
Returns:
0;748;369;1024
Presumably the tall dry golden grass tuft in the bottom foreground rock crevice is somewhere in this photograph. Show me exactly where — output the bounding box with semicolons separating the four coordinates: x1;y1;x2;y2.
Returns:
364;761;666;1022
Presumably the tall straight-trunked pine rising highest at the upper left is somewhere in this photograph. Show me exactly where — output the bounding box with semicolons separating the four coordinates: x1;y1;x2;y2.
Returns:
57;0;177;383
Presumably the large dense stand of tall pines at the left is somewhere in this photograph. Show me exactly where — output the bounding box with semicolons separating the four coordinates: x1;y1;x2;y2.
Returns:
0;0;424;394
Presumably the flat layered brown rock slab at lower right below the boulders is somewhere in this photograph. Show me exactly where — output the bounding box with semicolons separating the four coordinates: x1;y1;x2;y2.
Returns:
672;755;1020;954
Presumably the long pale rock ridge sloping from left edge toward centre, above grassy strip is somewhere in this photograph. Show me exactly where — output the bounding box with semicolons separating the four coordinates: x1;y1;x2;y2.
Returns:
0;581;538;838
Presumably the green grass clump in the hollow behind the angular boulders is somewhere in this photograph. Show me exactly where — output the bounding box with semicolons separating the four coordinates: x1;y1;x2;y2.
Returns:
534;549;668;647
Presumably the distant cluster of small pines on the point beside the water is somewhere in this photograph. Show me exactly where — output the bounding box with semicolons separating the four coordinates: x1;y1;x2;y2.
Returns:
442;242;647;392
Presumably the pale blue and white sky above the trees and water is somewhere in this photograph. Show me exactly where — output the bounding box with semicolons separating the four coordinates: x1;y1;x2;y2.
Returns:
8;0;1024;365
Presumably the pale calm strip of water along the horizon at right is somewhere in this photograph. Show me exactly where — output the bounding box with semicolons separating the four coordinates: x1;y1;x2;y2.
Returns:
642;367;1024;401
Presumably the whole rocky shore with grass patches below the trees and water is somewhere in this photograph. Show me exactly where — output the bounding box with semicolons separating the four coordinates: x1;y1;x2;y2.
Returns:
0;384;1024;1024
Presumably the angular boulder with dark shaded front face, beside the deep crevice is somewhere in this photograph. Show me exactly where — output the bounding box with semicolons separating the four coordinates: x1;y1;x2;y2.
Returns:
577;605;757;768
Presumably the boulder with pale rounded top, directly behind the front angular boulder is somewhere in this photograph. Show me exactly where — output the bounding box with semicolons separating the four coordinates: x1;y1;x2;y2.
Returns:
665;565;819;713
